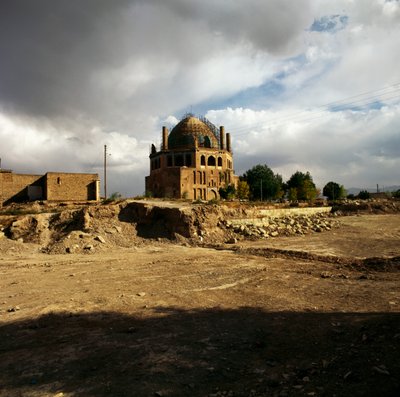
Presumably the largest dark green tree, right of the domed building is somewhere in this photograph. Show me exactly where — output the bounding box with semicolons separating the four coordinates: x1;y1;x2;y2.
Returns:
242;164;283;200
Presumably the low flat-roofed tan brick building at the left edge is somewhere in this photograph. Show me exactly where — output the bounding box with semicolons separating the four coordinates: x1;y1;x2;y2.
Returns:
0;169;100;205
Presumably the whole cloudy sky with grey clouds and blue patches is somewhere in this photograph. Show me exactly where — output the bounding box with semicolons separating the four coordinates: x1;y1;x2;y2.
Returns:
0;0;400;196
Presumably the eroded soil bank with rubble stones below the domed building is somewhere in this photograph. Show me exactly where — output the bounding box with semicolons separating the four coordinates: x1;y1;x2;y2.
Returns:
0;200;400;253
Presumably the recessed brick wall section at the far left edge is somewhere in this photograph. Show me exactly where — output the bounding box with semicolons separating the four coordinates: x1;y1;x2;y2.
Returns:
0;172;44;204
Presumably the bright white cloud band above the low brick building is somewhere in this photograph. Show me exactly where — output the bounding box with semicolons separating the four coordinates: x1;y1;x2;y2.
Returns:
0;113;149;195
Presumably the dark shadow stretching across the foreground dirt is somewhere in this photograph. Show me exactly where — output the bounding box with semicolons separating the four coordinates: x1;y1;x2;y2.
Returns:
0;308;400;397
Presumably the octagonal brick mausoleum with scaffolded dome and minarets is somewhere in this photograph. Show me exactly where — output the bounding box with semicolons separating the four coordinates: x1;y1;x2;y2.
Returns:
146;114;238;200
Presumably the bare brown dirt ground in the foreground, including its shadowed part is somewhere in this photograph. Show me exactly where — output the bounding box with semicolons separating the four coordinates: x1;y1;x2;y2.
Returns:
0;214;400;397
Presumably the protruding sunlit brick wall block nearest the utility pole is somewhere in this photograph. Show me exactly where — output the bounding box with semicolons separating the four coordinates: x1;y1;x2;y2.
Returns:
45;172;99;201
